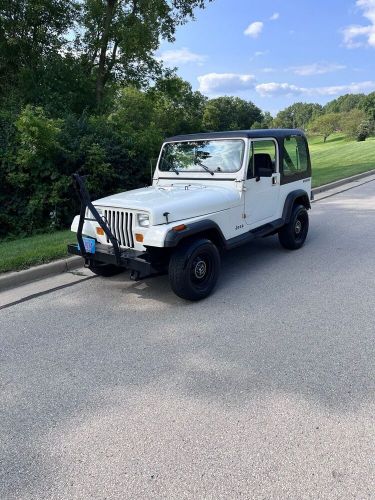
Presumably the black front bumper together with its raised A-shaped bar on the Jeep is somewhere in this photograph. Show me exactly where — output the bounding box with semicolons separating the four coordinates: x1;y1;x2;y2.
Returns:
68;174;160;280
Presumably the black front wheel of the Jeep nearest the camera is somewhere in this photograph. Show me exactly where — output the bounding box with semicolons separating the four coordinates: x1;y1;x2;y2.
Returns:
169;239;220;300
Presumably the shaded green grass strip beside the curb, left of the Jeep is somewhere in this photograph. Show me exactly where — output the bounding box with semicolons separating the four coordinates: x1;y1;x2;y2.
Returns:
0;231;75;273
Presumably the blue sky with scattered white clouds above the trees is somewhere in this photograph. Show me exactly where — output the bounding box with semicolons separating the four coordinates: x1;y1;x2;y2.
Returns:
158;0;375;114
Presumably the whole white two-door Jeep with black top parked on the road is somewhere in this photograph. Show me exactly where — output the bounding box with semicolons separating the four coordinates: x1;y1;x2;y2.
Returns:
68;129;311;300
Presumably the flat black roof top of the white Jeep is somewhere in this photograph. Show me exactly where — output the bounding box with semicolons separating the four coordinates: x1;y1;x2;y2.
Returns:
164;128;305;142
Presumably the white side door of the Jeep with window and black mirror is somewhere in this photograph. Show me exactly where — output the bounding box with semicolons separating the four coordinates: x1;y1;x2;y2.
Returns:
245;139;280;227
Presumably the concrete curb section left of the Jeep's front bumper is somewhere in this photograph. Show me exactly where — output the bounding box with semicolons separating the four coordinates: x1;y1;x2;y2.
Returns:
0;256;83;292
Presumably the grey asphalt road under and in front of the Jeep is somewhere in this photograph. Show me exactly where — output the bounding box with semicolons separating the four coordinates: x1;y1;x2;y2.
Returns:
0;182;375;500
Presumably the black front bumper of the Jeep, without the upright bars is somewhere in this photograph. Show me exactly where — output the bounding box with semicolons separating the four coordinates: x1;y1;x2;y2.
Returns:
68;243;160;279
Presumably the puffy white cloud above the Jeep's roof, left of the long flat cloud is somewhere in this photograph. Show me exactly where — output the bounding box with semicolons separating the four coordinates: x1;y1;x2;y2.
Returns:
198;73;255;94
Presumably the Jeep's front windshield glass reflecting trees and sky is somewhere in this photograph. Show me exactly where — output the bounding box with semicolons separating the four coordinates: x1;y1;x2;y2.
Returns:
159;139;245;175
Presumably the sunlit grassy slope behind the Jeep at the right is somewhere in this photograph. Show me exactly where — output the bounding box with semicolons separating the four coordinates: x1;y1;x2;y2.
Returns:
309;134;375;187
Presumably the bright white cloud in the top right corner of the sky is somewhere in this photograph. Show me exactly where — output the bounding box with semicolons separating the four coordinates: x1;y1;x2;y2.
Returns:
343;0;375;49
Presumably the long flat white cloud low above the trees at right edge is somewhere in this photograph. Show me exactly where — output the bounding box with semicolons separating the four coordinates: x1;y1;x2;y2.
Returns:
255;81;375;97
